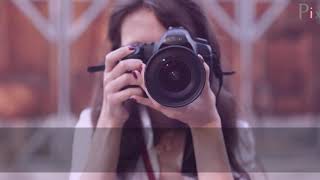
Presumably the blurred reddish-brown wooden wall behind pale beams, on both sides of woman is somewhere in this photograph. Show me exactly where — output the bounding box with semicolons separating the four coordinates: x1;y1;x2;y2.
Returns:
0;0;320;120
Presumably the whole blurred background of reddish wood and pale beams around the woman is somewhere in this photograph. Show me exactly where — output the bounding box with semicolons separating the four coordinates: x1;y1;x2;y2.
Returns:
0;0;320;179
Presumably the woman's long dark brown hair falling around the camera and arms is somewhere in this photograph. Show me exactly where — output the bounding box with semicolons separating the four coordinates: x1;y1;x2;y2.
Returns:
91;0;250;179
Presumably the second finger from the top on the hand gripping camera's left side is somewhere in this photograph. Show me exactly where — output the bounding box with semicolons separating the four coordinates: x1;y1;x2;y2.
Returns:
107;59;143;80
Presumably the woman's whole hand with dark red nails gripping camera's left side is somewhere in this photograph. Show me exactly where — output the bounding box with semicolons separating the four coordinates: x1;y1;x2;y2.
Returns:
97;46;143;128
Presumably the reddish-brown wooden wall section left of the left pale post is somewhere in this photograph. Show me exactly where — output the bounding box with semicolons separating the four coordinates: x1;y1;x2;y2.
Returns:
0;1;48;119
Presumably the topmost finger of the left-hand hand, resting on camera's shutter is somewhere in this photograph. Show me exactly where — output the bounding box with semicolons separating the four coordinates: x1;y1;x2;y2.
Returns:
105;46;134;72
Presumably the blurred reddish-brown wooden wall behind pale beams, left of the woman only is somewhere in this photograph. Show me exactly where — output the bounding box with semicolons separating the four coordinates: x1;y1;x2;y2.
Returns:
0;1;107;119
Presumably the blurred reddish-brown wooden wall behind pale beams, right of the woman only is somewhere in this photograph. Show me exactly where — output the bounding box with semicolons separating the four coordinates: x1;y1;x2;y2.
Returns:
208;2;320;116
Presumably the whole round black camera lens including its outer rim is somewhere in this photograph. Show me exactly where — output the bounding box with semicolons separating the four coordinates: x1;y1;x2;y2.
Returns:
144;45;206;107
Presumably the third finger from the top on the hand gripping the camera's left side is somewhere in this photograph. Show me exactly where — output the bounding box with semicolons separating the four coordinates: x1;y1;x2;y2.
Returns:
105;73;139;93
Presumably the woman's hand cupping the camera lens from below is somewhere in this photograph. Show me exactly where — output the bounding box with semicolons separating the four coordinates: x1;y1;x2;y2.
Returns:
131;55;221;127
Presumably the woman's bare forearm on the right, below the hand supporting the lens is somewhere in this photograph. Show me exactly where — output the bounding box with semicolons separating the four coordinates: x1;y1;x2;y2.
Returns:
191;116;233;180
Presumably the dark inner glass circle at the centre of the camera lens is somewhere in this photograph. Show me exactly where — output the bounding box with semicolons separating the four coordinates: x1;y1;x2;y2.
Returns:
160;59;191;92
